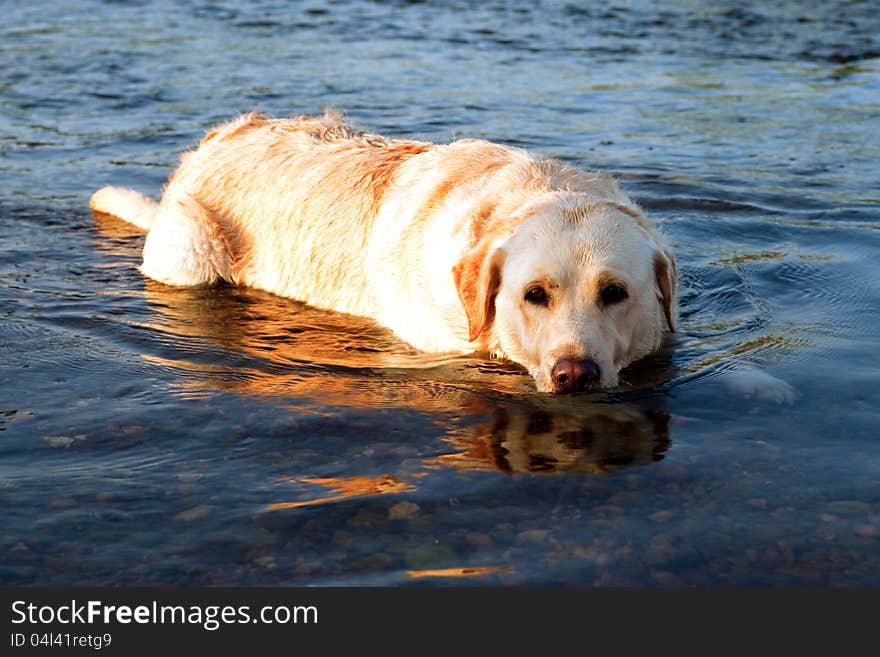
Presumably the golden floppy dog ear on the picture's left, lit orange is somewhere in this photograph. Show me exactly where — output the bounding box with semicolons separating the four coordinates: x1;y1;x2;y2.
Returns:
452;244;507;342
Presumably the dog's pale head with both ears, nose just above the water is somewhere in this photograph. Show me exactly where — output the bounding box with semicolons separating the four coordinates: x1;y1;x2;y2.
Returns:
453;192;676;392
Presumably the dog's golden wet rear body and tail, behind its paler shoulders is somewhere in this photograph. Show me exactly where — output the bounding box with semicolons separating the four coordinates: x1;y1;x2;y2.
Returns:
92;113;432;314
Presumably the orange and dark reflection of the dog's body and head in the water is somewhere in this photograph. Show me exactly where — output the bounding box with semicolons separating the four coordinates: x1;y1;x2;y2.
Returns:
97;215;671;474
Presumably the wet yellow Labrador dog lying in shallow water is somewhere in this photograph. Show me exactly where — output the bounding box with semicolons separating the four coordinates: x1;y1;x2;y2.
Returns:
90;112;677;393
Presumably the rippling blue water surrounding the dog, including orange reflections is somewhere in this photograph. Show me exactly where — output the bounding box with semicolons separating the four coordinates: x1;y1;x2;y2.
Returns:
0;0;880;586
